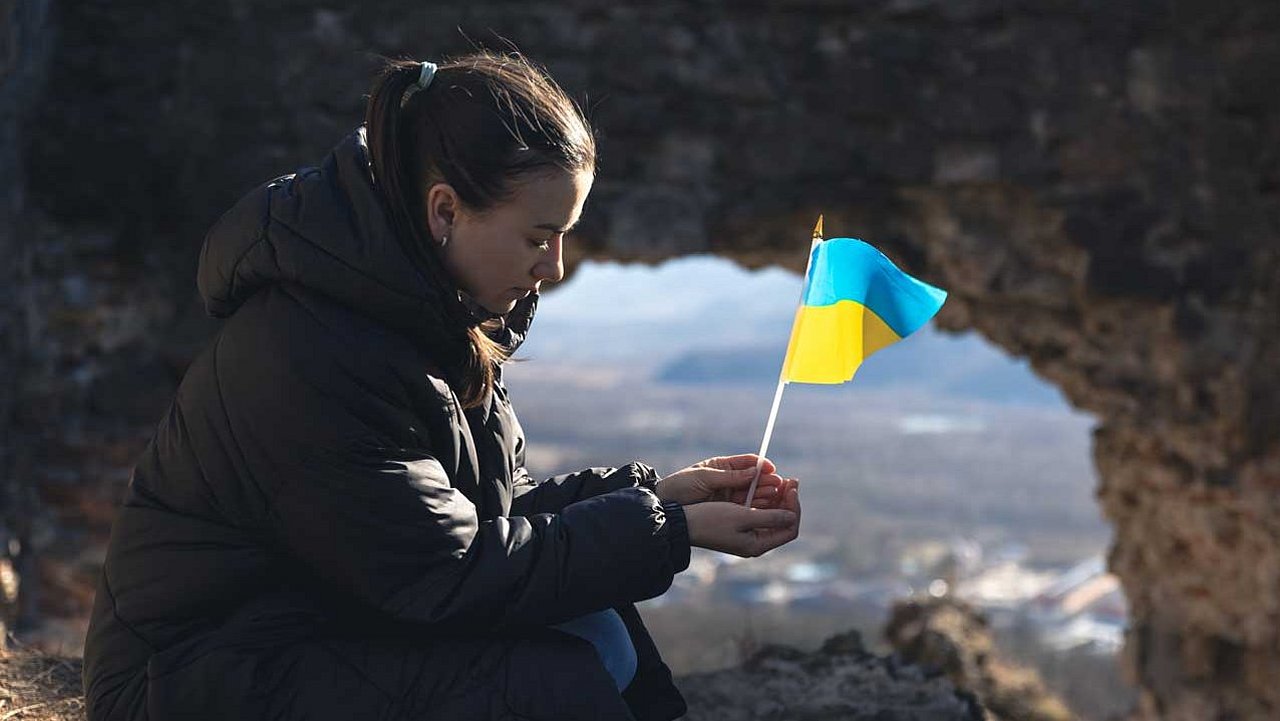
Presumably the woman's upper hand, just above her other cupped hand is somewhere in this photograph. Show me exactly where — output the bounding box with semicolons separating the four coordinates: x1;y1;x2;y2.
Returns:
657;453;782;508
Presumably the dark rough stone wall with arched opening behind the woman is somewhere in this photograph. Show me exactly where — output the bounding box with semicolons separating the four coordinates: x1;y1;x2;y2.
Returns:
0;0;1280;721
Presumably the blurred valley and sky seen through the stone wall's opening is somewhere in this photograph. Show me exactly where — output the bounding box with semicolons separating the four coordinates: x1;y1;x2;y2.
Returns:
504;256;1132;718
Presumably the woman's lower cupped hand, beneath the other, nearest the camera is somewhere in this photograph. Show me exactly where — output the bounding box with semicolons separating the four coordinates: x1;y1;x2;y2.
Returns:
685;478;800;558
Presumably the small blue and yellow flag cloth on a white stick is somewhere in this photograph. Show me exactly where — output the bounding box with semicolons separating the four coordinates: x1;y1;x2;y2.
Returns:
782;234;947;383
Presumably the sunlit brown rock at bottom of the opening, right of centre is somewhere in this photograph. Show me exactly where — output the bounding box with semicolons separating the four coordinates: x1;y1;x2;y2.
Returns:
884;598;1073;721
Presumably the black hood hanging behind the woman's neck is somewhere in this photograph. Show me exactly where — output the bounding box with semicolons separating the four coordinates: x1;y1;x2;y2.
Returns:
196;126;538;361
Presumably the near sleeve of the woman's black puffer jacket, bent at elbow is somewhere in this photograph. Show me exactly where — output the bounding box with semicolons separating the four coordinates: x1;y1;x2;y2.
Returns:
274;447;689;630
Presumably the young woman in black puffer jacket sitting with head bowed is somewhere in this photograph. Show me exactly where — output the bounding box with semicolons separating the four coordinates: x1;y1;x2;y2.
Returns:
84;53;800;721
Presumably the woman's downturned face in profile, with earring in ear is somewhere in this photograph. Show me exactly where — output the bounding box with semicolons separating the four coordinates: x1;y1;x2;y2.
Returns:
426;169;594;314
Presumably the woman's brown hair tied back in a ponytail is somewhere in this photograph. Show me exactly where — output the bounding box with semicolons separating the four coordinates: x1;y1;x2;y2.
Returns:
365;50;595;407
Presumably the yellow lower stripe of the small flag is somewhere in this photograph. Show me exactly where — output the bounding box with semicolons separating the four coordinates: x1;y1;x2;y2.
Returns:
782;300;902;383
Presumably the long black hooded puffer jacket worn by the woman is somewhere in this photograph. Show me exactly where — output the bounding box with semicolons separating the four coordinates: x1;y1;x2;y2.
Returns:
83;128;689;721
